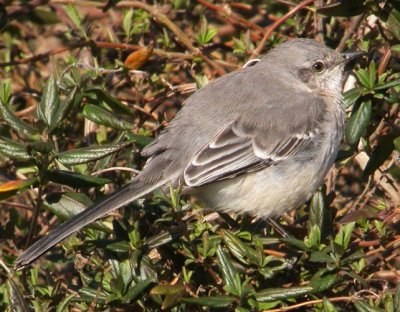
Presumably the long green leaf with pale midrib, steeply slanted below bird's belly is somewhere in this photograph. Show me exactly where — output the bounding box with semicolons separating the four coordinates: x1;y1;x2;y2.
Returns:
217;245;241;295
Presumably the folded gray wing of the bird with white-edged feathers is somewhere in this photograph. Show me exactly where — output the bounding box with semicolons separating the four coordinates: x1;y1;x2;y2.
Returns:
183;116;320;187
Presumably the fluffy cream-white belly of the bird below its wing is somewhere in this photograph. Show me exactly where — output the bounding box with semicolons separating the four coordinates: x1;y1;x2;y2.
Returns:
196;152;333;218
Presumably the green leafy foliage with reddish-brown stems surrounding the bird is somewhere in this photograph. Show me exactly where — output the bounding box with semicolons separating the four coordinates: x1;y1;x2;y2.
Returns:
0;0;400;311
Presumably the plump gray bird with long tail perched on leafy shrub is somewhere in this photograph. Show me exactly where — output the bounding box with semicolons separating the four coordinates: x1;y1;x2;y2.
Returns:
16;39;360;267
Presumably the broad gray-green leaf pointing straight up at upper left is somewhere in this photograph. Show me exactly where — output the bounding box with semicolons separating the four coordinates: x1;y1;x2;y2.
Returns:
36;75;60;128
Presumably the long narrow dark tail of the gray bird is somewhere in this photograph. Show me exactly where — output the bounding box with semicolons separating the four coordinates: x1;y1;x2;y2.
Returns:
15;179;165;269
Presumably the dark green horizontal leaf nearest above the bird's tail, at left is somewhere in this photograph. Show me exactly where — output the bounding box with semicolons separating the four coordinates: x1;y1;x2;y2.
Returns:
46;170;111;188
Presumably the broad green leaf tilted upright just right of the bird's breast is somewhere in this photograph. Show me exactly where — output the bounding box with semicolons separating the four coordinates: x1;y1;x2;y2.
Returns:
346;100;372;146
